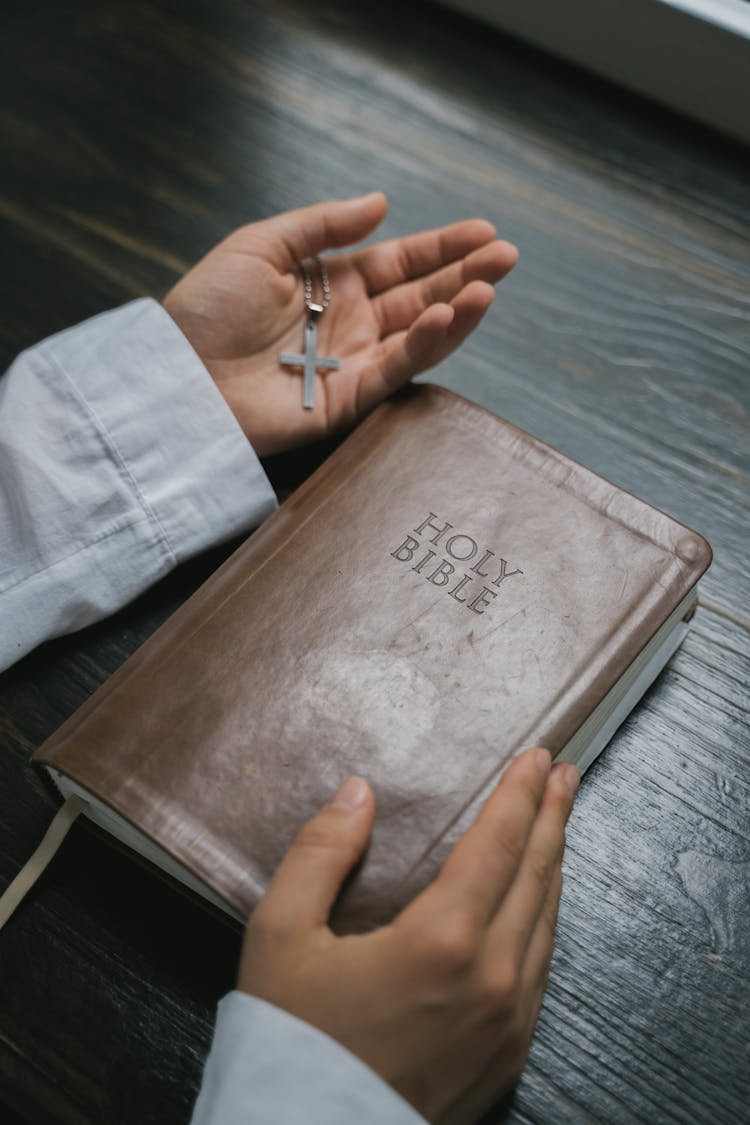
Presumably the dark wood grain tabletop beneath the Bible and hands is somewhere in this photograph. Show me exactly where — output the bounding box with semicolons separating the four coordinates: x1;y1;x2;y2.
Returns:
0;0;750;1125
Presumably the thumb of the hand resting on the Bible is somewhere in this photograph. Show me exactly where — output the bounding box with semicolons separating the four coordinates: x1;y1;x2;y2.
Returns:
257;777;374;934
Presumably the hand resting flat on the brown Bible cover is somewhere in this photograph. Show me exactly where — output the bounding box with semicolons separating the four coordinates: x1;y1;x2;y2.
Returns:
238;749;579;1125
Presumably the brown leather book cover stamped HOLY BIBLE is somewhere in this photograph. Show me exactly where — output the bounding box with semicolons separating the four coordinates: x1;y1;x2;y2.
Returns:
34;384;711;929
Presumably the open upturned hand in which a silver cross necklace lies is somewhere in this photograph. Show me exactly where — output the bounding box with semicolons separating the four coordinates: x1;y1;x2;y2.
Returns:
164;192;517;457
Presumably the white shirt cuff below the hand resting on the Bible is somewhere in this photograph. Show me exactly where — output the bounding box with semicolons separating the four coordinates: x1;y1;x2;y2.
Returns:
191;991;425;1125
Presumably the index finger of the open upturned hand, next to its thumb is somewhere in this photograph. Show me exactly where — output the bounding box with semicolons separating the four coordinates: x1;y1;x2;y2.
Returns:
354;218;495;296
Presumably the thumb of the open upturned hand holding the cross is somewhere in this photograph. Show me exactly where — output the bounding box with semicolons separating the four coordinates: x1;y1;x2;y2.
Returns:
253;191;388;270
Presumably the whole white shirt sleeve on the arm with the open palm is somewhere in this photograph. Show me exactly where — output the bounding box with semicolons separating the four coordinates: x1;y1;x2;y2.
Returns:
0;298;277;668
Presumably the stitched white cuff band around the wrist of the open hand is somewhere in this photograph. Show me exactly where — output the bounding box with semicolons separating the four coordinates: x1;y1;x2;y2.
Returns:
40;297;277;563
